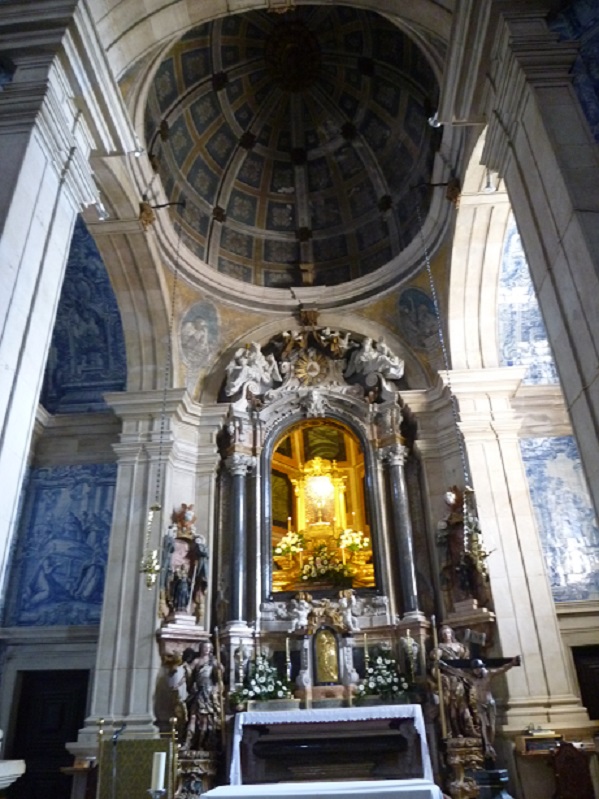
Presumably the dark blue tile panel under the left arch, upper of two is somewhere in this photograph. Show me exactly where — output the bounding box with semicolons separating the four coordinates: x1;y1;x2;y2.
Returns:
41;219;127;413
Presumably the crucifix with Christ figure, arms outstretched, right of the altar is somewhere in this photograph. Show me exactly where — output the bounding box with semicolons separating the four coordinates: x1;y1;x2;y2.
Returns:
439;655;520;761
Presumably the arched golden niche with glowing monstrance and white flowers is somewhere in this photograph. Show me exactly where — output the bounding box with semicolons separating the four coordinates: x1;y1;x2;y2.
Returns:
271;420;375;592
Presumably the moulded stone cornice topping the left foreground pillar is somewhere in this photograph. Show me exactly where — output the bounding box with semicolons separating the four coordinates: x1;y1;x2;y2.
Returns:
0;0;135;210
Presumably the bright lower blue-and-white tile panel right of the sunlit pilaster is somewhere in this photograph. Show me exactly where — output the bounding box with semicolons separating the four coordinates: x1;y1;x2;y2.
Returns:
520;436;599;602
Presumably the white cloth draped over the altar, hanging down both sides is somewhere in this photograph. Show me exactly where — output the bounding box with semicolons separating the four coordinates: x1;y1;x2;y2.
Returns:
229;705;433;780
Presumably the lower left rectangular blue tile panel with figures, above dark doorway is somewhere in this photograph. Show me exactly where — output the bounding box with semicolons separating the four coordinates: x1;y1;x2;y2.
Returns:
7;464;117;626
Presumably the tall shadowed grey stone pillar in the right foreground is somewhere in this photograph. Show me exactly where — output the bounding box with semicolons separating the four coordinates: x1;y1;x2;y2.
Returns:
481;0;599;516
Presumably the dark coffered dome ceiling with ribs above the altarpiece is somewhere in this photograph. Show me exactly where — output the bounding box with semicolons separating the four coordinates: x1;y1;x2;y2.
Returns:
145;6;438;288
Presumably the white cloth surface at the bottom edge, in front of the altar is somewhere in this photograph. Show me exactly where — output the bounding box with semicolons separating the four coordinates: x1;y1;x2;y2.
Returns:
202;780;443;799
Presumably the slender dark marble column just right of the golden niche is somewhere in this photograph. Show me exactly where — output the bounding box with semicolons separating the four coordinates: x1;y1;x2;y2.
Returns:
384;444;422;619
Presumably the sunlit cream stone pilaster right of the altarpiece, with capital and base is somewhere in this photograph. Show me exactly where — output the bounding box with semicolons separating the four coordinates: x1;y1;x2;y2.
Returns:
451;369;590;731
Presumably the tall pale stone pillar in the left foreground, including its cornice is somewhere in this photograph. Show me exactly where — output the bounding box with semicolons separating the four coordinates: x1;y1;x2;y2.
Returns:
0;0;133;590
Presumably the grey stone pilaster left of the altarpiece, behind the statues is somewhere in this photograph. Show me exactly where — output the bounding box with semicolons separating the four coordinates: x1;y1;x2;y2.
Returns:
74;389;206;746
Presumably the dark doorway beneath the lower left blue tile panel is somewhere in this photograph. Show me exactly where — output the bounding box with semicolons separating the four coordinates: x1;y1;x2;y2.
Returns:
6;670;89;799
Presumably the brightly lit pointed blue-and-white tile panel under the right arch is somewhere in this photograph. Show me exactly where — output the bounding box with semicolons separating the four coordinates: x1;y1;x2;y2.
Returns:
497;218;558;384
